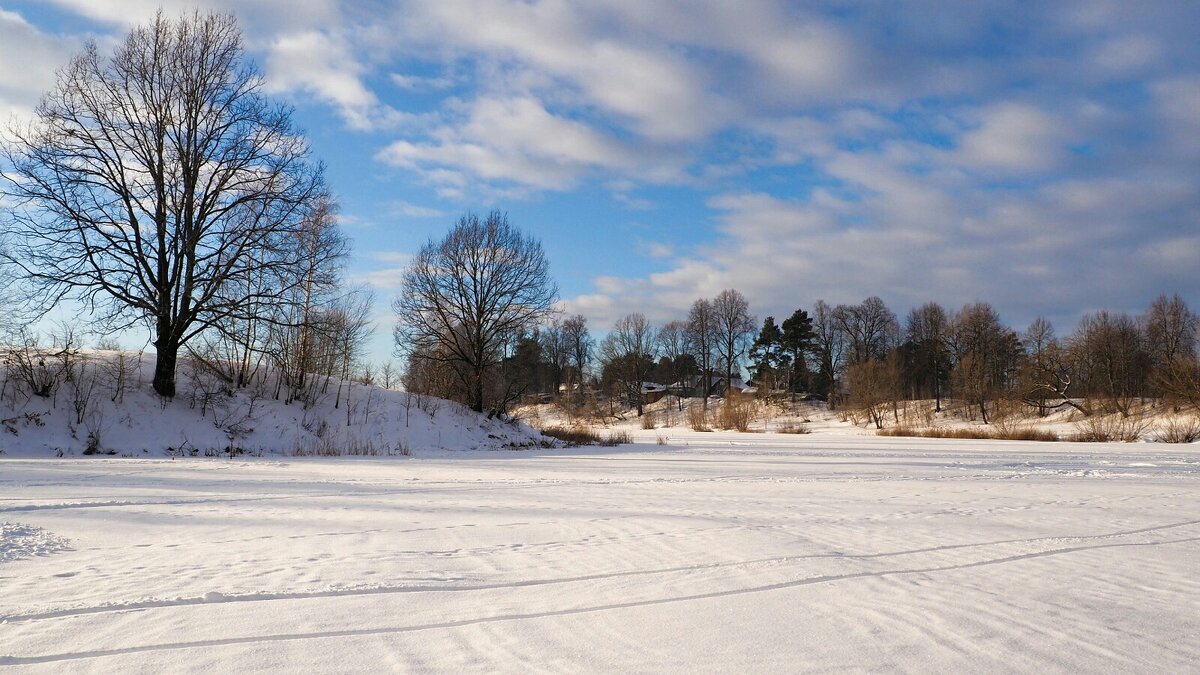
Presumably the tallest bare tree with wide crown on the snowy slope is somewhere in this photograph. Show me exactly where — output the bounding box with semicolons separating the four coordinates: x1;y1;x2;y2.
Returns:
4;12;323;396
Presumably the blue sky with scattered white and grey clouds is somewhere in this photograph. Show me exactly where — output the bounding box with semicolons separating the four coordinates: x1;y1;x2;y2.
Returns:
0;0;1200;358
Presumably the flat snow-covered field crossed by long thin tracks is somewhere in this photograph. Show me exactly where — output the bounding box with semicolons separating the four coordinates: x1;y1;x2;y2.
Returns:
0;431;1200;673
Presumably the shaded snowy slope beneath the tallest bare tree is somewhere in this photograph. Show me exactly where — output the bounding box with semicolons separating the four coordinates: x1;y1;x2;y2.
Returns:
0;352;546;458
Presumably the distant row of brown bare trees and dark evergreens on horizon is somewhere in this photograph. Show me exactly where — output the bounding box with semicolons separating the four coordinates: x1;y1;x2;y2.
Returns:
404;289;1200;428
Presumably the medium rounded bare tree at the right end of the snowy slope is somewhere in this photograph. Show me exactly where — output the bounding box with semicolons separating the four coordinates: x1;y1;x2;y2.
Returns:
392;211;558;412
